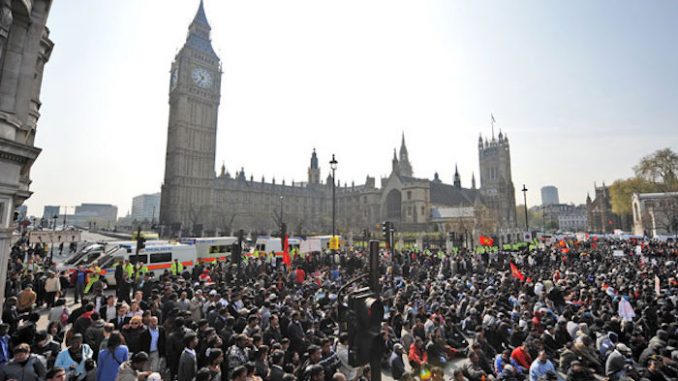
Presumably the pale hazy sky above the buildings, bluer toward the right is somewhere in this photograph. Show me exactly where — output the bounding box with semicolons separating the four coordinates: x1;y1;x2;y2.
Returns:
23;0;678;215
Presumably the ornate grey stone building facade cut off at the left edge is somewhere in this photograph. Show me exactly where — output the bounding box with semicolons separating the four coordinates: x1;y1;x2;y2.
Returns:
0;0;54;302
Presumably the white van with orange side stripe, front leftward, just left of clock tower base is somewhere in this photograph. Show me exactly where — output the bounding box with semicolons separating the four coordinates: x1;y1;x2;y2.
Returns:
97;243;197;286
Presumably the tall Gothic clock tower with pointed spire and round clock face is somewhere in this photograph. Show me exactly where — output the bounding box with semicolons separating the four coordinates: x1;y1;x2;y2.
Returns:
160;0;221;234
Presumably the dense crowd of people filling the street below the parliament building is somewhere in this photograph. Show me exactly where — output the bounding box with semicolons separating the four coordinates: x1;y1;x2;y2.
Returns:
0;232;678;381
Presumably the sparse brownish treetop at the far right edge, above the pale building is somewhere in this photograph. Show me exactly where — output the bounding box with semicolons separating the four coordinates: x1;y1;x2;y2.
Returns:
633;148;678;192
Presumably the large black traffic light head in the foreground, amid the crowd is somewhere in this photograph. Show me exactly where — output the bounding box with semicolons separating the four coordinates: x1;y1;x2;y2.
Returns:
344;288;384;367
